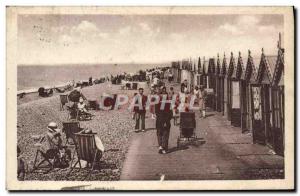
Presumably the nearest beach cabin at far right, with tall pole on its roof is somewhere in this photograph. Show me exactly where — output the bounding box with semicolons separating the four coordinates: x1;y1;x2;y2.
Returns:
271;40;284;156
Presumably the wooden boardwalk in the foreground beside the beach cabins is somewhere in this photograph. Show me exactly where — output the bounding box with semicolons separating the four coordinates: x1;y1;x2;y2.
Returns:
121;112;284;180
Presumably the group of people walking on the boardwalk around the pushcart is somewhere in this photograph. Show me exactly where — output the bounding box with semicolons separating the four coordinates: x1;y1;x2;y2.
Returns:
133;81;207;154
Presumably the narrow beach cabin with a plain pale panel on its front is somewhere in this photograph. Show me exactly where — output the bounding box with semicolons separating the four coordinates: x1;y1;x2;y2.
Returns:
230;52;243;127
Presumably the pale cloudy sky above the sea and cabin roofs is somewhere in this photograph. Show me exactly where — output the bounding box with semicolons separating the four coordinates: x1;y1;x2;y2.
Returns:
18;15;283;64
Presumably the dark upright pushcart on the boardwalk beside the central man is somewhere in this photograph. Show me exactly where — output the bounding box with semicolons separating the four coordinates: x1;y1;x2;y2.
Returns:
177;112;197;148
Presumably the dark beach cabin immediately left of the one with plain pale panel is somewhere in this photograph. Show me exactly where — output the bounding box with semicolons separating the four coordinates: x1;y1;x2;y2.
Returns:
226;52;237;121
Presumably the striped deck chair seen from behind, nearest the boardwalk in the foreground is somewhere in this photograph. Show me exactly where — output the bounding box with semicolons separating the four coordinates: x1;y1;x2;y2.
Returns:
67;133;104;180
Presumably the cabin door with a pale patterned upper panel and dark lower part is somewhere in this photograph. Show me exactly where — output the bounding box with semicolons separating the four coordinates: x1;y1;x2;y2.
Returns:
251;85;266;144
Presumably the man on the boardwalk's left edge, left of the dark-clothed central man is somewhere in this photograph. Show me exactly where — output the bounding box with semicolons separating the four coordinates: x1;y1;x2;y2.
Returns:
134;88;147;132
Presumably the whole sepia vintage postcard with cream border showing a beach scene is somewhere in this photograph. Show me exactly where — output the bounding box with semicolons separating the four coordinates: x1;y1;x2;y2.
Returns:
6;6;295;190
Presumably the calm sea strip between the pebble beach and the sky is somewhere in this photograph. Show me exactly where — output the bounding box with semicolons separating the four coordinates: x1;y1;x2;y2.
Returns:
17;63;169;91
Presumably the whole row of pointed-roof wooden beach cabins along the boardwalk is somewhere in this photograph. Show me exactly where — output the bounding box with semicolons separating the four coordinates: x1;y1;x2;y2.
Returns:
171;36;284;156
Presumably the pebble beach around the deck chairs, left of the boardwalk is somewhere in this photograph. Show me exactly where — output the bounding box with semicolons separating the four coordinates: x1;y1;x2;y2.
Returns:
17;83;147;181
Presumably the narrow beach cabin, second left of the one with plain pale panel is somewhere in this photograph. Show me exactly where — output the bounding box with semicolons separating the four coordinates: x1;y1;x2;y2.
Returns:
220;53;228;118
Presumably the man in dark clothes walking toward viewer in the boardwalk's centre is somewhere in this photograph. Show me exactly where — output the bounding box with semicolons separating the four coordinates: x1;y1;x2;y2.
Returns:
155;87;172;154
